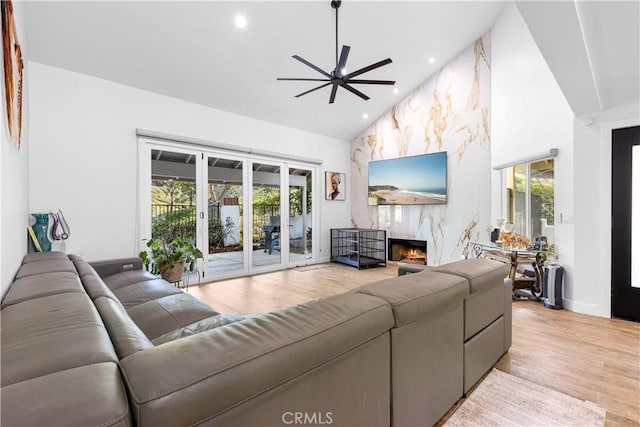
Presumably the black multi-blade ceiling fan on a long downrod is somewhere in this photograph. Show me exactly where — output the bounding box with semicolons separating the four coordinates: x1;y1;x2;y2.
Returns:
278;0;396;104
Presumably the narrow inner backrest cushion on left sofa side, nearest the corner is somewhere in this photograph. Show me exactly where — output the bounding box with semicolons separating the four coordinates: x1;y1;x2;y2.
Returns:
94;297;153;359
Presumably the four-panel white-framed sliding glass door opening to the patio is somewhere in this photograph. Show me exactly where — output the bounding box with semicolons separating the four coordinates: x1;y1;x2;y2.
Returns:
139;140;318;280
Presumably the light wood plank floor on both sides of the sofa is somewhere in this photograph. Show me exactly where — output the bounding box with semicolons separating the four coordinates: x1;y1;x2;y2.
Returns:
189;264;640;426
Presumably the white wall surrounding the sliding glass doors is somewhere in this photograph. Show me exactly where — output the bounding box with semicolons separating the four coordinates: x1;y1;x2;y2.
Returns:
29;62;350;260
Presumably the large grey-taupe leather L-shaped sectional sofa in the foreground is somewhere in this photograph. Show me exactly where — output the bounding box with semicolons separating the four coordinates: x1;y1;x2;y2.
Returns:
0;253;511;426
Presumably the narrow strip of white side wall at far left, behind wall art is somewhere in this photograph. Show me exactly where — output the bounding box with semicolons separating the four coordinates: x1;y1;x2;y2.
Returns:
0;2;30;296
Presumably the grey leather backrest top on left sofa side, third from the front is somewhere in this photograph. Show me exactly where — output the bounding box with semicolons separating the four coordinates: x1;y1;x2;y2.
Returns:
2;271;85;307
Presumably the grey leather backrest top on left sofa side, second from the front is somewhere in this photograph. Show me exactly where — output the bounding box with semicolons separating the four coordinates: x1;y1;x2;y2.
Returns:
0;293;118;386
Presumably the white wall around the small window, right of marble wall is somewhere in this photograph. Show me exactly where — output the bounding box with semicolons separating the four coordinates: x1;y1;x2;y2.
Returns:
491;4;576;304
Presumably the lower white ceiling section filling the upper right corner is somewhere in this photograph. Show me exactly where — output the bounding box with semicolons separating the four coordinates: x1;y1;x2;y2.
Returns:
516;0;640;116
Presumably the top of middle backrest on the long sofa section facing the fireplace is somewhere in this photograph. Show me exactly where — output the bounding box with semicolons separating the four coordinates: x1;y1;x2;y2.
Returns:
355;271;469;327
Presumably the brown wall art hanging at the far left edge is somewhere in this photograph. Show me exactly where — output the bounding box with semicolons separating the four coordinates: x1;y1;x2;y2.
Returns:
0;0;22;149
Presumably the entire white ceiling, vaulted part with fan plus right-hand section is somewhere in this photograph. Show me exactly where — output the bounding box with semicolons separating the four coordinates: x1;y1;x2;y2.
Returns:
20;0;640;140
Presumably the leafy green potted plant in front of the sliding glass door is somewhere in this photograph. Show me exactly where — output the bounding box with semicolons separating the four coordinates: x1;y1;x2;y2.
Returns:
138;237;202;282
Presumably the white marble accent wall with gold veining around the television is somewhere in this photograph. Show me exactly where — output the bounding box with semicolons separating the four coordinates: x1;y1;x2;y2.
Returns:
349;34;491;265
